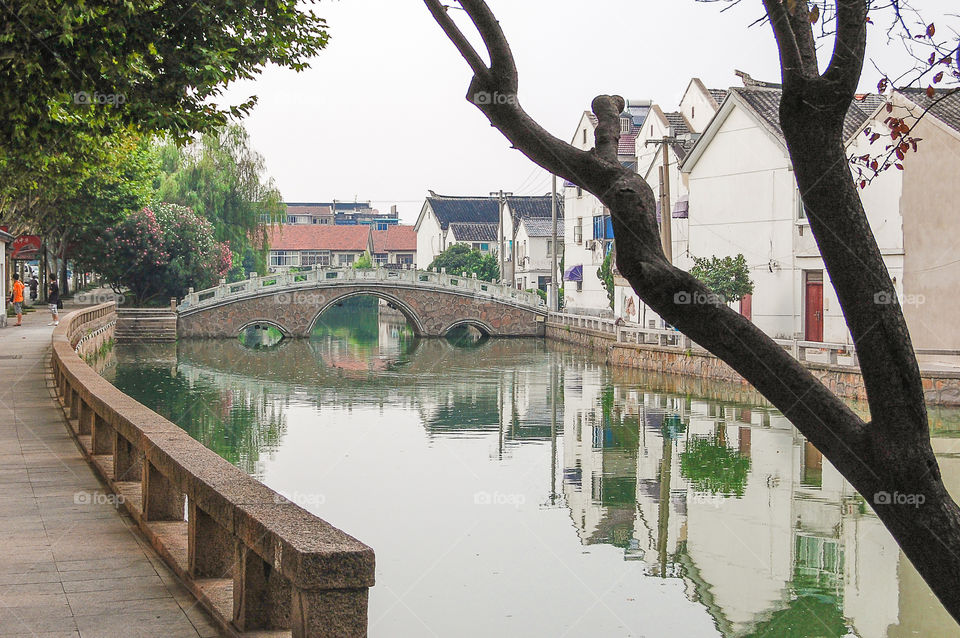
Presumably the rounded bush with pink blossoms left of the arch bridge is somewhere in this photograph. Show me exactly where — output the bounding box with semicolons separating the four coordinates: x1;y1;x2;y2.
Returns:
91;204;231;305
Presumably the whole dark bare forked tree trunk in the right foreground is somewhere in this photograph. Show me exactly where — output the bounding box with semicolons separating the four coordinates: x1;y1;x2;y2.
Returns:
424;0;960;620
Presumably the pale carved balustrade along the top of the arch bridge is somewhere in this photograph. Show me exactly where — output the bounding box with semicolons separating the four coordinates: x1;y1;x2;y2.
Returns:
177;267;546;312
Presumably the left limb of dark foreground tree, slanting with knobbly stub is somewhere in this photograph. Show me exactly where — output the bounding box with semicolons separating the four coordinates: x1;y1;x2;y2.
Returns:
424;0;872;480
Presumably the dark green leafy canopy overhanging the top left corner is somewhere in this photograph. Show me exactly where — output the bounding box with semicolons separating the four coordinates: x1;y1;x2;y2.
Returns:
0;0;327;154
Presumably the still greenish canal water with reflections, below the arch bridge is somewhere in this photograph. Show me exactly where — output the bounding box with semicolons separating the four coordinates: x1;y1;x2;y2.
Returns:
102;302;960;638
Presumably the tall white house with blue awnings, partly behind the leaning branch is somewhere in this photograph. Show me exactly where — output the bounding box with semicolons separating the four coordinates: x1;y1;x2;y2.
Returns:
563;100;651;315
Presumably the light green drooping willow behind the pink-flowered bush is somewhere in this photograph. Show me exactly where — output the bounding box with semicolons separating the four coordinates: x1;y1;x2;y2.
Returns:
158;124;286;280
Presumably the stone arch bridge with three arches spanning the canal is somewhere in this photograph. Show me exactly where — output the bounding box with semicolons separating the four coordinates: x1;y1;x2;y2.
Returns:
177;268;547;338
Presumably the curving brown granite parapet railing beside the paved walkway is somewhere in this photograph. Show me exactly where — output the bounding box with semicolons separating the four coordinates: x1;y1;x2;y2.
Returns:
52;303;374;638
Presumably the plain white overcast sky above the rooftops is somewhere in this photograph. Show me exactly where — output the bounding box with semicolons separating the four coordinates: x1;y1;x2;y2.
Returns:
223;0;958;223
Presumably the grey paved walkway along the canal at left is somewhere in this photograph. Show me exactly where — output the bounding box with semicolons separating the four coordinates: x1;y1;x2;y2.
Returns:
0;306;220;638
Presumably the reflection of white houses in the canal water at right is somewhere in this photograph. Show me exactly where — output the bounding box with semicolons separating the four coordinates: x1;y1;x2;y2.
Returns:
562;364;960;638
